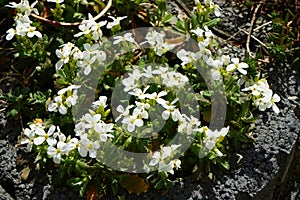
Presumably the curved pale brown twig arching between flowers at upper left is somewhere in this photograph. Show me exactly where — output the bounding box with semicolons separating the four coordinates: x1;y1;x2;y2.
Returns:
30;0;112;26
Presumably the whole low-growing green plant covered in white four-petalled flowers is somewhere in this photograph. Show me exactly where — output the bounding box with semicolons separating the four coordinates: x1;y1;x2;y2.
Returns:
1;0;280;196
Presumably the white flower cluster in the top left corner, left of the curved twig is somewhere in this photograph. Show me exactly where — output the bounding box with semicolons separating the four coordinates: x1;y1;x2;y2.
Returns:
6;0;42;40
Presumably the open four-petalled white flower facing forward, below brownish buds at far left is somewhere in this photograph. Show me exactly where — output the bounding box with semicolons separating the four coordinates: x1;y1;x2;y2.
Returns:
33;125;57;146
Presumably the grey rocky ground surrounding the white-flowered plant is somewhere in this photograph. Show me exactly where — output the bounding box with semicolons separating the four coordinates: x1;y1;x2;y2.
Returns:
0;0;300;200
